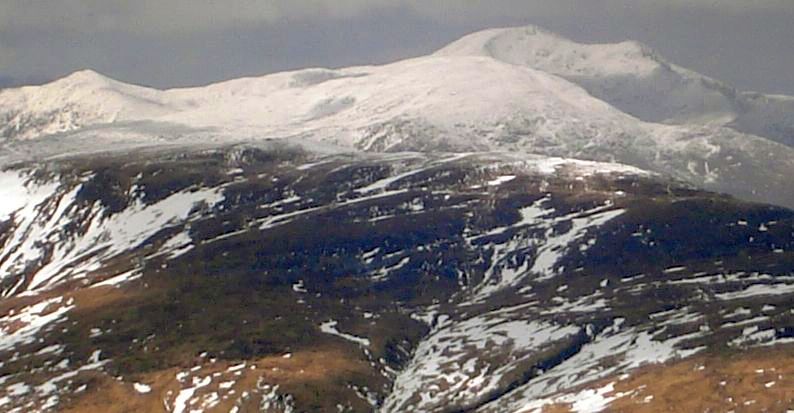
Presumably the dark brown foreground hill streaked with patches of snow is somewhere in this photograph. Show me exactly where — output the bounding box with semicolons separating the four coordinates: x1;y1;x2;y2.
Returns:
0;145;794;412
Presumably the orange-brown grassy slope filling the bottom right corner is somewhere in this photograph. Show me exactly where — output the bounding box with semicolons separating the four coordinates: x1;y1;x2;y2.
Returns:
543;346;794;413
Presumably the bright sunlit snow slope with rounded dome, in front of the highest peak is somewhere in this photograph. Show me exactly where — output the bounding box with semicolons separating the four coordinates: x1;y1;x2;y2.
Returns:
0;56;632;150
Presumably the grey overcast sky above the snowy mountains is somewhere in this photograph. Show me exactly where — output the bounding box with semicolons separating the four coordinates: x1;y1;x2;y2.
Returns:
0;0;794;95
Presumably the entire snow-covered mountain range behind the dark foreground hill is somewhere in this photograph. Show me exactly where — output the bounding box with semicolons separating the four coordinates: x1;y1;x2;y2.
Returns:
0;27;794;212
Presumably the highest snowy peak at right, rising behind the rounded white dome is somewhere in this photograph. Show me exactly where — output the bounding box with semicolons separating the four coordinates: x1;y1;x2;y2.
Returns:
436;26;794;146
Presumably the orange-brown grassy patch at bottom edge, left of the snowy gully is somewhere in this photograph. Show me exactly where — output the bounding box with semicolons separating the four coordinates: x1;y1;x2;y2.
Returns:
61;346;368;413
